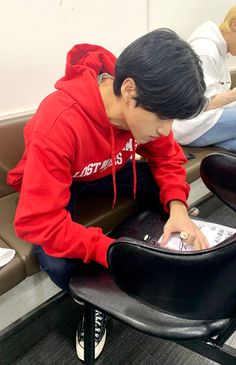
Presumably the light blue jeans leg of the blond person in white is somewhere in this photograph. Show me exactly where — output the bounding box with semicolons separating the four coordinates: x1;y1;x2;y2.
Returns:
186;107;236;152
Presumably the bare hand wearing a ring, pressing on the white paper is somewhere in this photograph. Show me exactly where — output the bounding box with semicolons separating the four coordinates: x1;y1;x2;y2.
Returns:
160;200;209;250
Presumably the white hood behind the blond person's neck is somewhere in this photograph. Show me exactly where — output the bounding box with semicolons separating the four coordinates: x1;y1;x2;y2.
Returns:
188;20;227;56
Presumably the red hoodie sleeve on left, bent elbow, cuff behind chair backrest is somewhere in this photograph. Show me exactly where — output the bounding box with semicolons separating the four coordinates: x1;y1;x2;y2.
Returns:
15;132;113;266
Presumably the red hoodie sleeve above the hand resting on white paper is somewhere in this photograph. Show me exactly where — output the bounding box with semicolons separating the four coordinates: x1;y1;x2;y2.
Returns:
137;132;190;212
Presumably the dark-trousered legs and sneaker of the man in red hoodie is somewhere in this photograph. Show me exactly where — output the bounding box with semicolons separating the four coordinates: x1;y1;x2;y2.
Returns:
34;160;164;360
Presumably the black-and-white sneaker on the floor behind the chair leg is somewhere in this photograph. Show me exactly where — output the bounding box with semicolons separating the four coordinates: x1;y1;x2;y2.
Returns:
76;310;106;361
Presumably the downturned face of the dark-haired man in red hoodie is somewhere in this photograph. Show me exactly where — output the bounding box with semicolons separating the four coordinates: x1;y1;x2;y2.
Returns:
124;99;173;144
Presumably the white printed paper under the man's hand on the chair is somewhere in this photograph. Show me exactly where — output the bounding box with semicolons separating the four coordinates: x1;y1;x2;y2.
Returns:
158;219;236;251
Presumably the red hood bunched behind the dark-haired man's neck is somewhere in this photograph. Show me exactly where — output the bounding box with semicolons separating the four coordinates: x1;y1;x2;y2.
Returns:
55;44;116;130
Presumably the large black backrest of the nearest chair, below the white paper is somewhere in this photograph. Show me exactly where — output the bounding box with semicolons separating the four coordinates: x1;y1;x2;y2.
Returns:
108;234;236;320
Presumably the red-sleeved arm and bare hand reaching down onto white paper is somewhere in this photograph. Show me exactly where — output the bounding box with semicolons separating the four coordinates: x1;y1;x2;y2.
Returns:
137;133;208;249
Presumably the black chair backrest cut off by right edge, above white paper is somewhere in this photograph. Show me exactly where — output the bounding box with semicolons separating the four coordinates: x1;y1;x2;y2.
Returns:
200;152;236;211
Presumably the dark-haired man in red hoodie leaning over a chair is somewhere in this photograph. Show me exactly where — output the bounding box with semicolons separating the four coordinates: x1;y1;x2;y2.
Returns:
8;29;207;359
